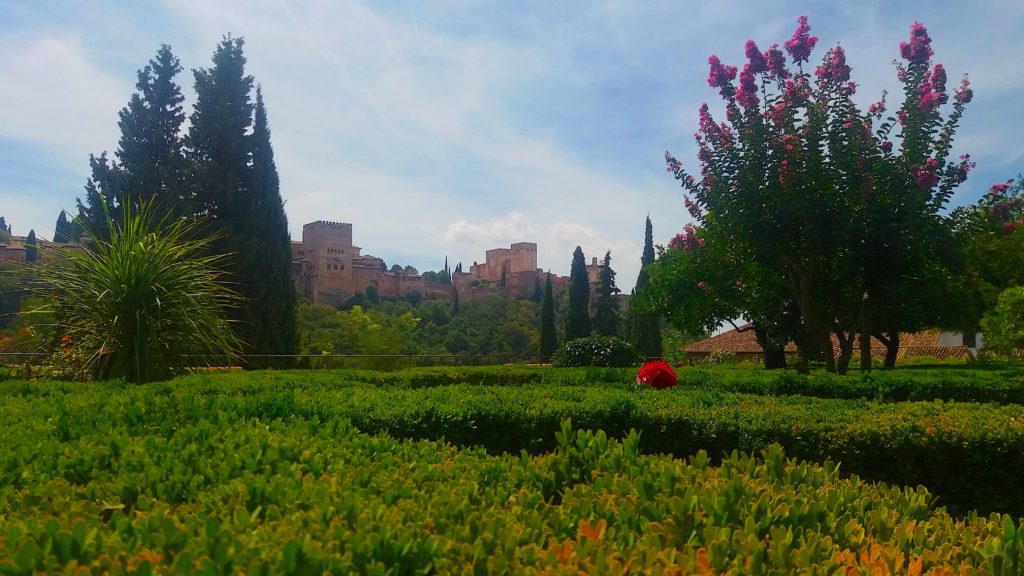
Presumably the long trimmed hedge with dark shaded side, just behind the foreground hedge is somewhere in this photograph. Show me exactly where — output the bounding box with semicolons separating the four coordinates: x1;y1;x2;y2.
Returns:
0;372;1024;516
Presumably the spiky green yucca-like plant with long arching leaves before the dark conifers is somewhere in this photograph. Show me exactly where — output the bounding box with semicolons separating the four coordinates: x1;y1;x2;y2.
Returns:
29;203;241;383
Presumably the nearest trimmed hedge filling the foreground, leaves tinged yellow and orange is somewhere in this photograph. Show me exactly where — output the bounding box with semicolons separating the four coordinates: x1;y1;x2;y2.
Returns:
0;385;1024;574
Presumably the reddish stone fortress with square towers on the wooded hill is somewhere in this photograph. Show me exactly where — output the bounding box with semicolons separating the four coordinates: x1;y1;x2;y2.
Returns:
292;220;585;306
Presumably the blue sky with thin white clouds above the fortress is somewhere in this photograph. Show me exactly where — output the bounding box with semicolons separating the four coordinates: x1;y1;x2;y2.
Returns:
0;0;1024;292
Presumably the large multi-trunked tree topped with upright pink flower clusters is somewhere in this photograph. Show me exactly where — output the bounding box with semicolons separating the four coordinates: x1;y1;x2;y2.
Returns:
666;16;974;372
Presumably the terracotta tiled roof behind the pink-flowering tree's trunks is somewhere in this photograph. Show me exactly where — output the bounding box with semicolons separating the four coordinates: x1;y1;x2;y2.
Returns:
683;323;971;360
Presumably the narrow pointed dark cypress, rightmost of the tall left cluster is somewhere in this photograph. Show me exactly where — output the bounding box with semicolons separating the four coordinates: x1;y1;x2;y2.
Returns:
240;86;298;354
